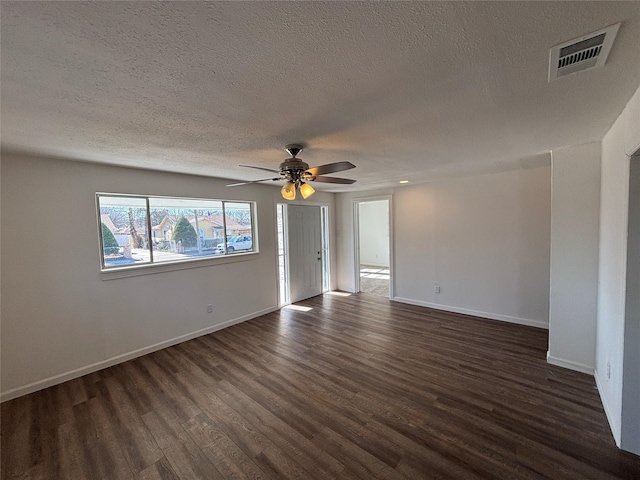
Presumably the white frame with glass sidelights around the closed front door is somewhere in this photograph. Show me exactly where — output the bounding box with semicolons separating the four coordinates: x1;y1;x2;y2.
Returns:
274;199;333;307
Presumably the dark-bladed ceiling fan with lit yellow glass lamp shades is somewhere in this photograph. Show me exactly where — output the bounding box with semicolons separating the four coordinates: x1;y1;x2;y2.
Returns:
227;143;356;200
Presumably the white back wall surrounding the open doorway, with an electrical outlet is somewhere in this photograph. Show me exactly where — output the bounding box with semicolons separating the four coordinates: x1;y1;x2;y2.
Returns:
336;166;551;327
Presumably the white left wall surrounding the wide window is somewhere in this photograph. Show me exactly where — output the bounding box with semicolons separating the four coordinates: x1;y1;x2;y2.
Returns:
1;153;334;399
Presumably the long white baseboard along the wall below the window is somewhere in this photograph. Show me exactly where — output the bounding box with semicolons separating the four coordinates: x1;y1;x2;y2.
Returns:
0;307;280;402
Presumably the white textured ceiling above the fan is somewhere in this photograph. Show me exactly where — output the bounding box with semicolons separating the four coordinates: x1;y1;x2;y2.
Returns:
0;1;640;191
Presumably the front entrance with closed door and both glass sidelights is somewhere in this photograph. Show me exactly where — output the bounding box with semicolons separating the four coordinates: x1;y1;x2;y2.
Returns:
277;204;330;306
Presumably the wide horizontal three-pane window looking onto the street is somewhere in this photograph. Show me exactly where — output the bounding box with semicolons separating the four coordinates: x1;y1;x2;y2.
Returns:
96;193;257;269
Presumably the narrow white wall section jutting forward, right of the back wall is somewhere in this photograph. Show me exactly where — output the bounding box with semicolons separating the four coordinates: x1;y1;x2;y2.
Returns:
547;142;601;374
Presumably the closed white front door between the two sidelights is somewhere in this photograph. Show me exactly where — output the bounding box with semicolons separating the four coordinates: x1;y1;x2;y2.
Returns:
287;205;322;303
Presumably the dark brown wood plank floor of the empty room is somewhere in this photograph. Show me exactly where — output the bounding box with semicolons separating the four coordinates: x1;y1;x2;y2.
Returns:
1;294;640;480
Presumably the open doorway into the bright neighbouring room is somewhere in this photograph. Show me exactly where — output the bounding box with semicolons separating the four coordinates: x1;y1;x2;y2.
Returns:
356;198;391;298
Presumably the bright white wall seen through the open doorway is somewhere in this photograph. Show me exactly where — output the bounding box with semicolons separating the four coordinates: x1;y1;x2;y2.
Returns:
358;200;389;267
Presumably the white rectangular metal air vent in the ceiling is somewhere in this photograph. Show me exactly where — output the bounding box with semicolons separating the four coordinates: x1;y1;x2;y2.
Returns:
549;23;620;81
